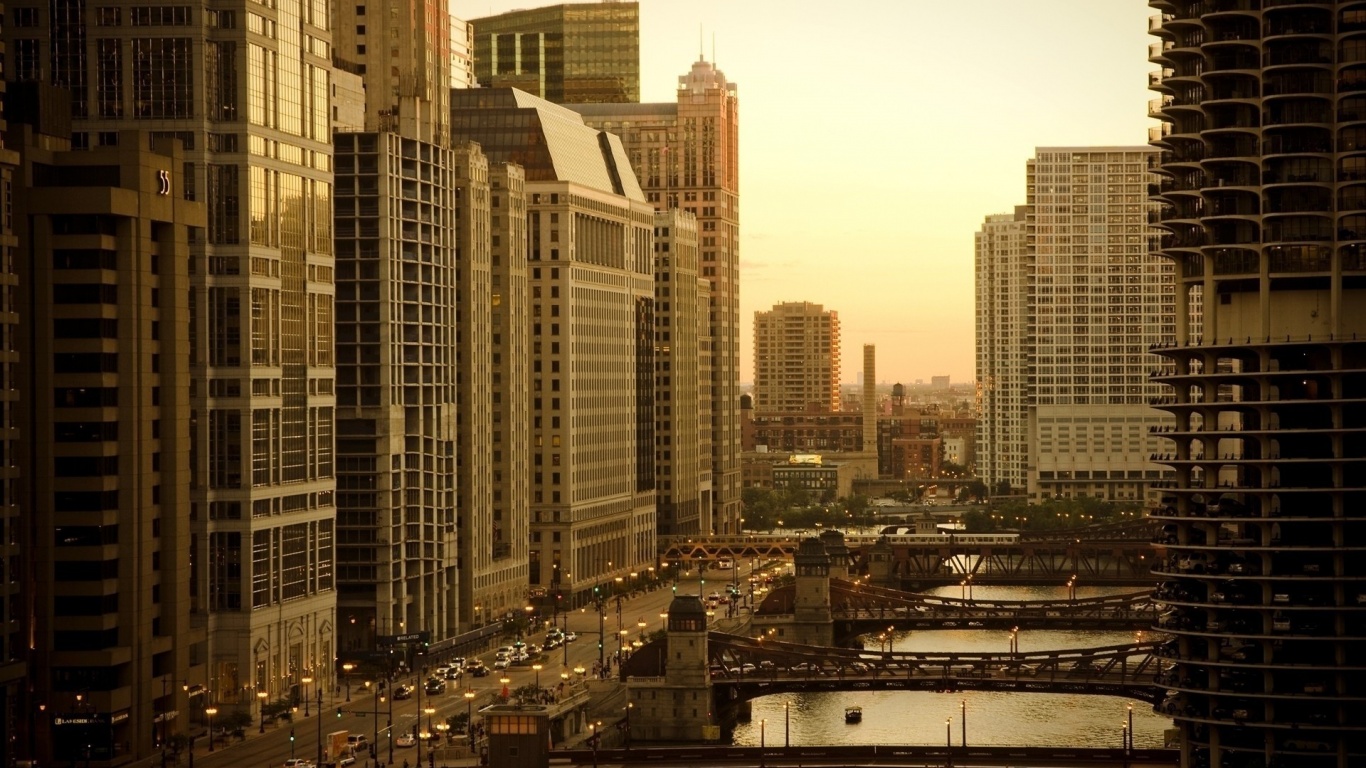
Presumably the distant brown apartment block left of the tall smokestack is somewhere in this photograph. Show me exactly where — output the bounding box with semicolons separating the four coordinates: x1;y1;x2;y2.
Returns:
754;302;840;415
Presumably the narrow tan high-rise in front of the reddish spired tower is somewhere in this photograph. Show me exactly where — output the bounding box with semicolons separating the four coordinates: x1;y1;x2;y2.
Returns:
654;209;712;536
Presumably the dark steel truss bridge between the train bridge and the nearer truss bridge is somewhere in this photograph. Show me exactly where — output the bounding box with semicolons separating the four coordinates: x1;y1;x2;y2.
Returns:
754;578;1158;638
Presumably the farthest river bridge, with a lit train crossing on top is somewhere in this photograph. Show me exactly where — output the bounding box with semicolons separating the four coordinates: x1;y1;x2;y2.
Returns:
660;519;1156;586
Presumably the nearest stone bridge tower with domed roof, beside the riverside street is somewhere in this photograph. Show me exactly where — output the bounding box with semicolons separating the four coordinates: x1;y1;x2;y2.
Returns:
626;594;717;742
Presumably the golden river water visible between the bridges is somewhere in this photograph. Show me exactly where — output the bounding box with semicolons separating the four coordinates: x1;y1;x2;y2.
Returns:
734;586;1172;749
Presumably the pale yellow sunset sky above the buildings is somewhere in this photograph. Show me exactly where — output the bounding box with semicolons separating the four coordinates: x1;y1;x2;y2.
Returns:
467;0;1153;384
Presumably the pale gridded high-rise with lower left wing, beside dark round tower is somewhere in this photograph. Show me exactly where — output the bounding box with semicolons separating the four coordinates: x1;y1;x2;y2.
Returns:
977;146;1173;502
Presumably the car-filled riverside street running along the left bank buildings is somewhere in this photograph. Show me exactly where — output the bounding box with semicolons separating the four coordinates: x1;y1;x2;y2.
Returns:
181;562;770;768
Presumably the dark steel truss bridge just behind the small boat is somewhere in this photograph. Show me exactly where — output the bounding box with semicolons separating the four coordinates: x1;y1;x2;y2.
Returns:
622;631;1162;707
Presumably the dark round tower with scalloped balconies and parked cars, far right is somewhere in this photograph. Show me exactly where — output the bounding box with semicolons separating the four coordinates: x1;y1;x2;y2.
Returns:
1149;0;1366;768
